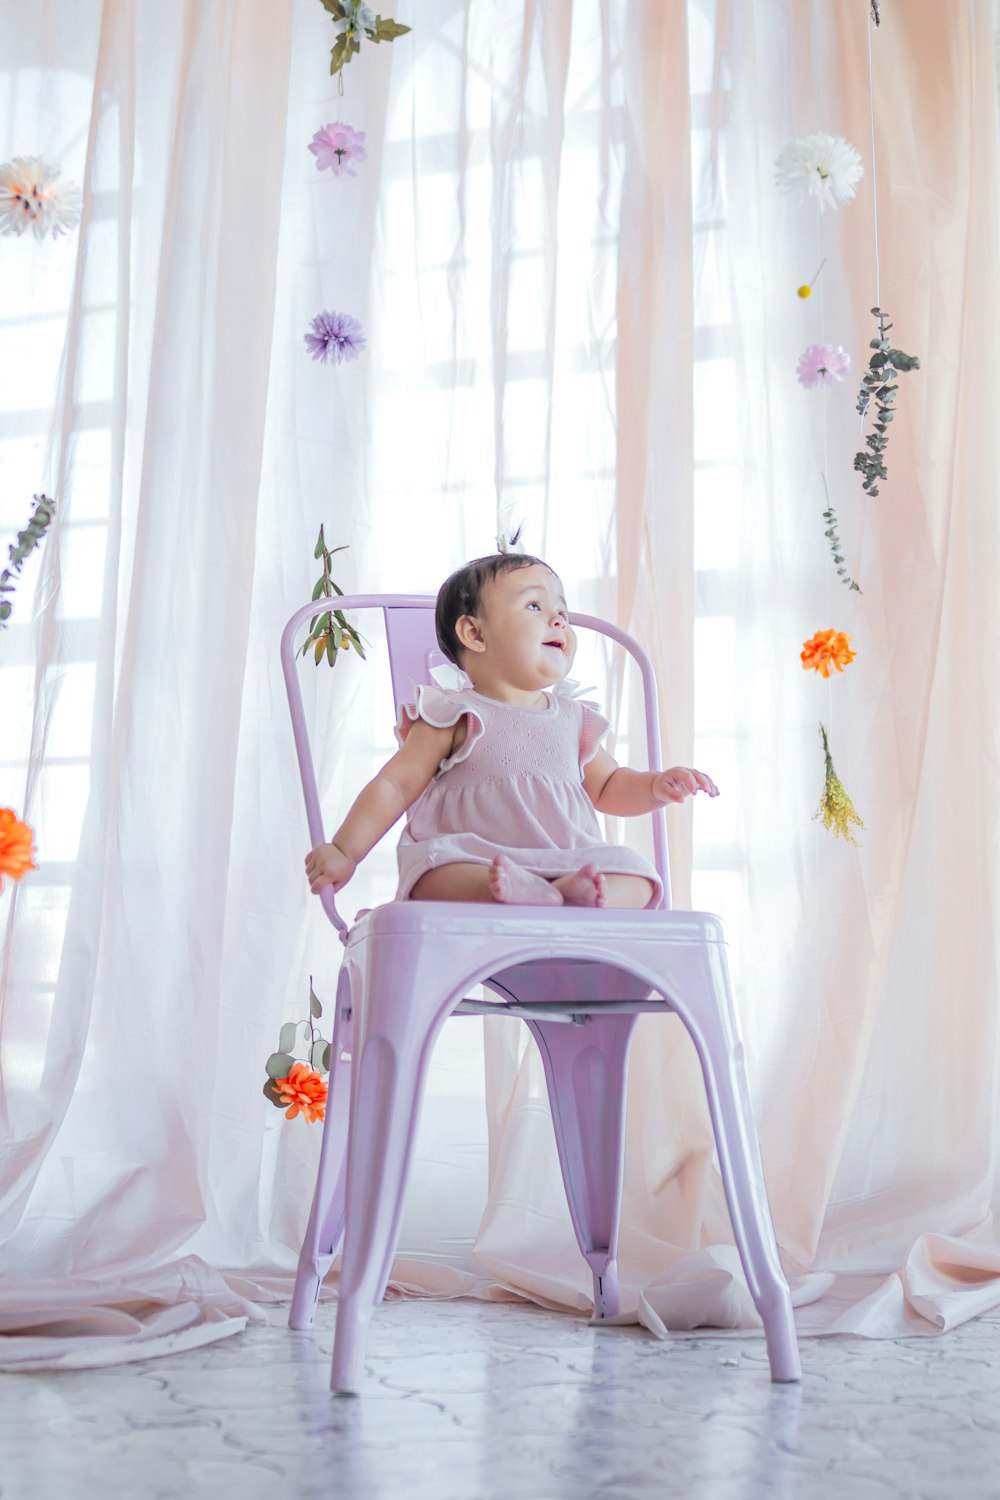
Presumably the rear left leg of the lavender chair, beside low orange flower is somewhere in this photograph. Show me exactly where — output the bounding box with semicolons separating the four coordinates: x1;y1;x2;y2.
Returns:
288;969;352;1329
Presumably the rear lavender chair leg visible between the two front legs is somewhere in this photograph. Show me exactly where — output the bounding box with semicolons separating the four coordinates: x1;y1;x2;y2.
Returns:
528;1014;636;1319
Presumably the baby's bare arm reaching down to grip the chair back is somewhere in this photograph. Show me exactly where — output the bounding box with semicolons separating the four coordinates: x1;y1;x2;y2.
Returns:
306;719;465;896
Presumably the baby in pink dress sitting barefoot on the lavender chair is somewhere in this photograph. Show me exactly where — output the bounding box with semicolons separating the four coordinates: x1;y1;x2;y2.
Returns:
306;552;718;908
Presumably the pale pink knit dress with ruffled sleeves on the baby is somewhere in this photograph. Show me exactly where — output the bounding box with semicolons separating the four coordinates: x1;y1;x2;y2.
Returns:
396;687;663;906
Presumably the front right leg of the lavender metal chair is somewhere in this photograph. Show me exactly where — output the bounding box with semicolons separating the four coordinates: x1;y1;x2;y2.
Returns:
681;987;802;1382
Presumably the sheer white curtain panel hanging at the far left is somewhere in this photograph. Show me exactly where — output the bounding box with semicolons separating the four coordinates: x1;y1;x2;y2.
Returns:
0;0;291;1314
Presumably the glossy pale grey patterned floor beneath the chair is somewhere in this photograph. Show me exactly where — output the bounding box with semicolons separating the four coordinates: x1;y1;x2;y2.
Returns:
0;1302;1000;1500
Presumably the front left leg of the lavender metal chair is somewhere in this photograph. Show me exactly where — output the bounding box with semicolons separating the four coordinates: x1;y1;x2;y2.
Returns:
330;992;438;1394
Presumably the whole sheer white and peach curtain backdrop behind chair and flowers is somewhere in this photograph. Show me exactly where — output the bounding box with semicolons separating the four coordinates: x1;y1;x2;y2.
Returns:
0;0;1000;1362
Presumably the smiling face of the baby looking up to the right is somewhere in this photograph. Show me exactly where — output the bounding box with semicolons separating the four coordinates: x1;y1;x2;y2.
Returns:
481;563;576;689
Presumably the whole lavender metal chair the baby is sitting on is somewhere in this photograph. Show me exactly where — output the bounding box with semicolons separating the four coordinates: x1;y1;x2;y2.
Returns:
282;594;801;1392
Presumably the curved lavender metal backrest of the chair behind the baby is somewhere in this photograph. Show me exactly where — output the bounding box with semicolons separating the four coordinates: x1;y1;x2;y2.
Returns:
282;594;670;935
